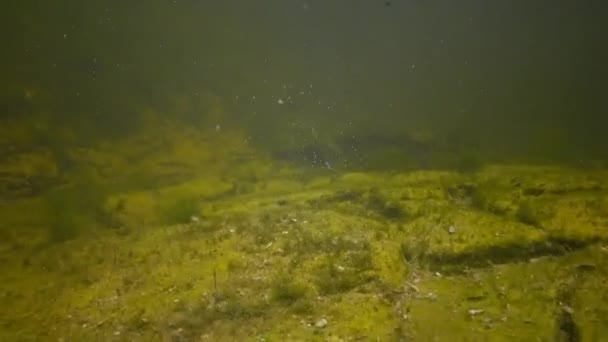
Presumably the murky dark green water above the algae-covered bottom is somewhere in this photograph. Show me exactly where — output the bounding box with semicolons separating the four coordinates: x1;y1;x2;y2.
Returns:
0;0;608;162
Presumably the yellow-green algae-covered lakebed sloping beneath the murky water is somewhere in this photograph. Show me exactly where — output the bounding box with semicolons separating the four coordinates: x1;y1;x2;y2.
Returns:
0;123;608;341
